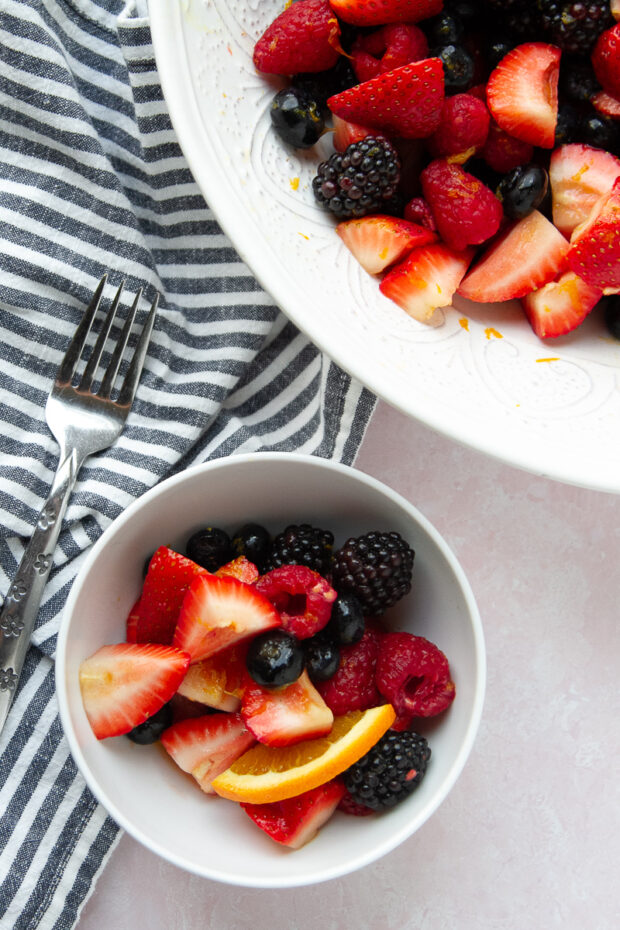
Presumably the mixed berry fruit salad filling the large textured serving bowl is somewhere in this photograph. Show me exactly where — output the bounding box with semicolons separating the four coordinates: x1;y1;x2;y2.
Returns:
254;0;620;338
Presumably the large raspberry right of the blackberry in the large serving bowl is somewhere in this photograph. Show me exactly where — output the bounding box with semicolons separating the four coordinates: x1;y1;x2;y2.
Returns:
420;160;503;251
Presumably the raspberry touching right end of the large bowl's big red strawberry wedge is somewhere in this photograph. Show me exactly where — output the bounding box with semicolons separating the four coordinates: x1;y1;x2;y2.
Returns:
428;94;491;158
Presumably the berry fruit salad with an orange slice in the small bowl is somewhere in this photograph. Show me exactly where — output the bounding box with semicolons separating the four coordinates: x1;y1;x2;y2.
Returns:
79;523;455;849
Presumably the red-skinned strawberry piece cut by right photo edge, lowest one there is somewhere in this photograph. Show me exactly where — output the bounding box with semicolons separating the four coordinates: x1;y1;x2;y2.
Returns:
567;178;620;288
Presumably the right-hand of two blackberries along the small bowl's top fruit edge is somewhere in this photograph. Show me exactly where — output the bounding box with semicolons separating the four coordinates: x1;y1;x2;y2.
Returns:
332;531;415;616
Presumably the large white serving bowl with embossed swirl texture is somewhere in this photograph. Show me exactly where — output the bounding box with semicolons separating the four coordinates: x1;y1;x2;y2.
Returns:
149;0;620;493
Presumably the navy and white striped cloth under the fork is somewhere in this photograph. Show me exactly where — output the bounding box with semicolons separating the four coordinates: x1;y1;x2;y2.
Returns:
0;0;374;930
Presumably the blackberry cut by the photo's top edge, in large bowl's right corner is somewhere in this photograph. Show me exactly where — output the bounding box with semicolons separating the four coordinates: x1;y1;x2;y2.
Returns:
538;0;615;55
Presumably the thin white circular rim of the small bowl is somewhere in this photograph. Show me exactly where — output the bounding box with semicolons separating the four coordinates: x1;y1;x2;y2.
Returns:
56;452;486;888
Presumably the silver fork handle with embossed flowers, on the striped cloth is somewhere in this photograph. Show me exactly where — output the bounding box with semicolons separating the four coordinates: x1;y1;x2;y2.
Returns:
0;452;82;731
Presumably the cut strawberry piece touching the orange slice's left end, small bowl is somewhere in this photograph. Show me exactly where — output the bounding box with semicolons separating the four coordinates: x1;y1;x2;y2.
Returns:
161;714;255;794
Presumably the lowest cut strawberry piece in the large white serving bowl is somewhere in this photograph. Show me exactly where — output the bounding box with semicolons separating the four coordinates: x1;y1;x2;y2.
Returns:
521;271;603;339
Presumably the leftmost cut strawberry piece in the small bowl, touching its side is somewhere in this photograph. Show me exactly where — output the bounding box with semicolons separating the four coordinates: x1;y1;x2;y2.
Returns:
79;643;189;739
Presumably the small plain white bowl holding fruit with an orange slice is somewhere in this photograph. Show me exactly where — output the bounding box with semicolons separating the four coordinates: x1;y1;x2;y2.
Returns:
56;453;486;888
